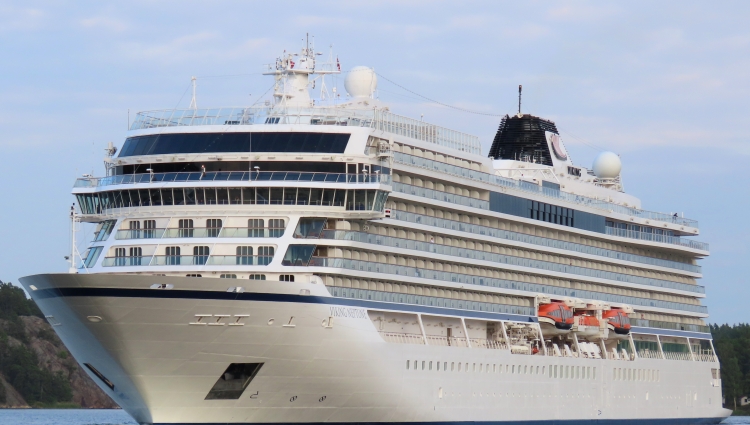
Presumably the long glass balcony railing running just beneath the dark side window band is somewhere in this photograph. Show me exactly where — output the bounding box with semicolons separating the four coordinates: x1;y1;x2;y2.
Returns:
391;210;708;262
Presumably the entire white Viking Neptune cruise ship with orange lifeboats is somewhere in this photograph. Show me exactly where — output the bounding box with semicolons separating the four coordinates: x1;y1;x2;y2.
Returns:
21;40;731;424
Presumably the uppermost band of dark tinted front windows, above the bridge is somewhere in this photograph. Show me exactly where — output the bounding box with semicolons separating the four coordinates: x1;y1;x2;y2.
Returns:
118;133;350;157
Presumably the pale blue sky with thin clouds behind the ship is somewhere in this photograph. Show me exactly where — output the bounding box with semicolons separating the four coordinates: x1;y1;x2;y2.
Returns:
0;0;750;323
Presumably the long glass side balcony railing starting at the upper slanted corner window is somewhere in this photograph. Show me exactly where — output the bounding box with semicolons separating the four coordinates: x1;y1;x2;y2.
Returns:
320;230;705;294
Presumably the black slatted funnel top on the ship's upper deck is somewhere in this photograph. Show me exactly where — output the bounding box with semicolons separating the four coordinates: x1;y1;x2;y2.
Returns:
489;114;559;165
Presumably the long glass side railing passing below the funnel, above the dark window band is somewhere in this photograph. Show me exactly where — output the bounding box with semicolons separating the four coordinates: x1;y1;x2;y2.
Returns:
393;152;698;228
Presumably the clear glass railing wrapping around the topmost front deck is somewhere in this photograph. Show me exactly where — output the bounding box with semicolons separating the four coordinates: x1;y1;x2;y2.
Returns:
130;107;482;155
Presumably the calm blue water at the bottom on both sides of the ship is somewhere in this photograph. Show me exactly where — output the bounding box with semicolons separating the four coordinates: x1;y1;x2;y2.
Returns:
0;409;750;425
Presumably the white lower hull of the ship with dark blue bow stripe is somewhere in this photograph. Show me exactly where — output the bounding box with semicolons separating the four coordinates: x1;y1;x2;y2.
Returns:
21;275;730;424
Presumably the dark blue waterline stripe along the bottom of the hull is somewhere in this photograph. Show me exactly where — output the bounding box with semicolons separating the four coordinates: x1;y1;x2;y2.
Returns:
154;417;724;425
